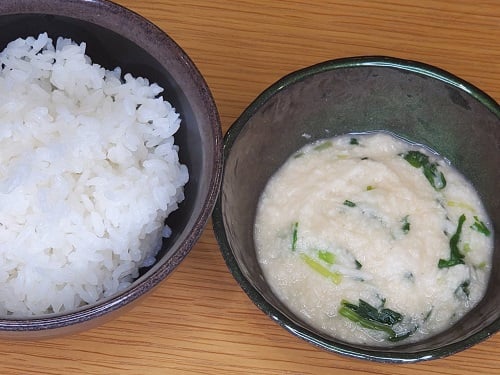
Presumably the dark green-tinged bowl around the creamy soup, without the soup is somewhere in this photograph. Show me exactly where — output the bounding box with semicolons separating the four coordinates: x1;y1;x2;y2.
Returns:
213;57;500;362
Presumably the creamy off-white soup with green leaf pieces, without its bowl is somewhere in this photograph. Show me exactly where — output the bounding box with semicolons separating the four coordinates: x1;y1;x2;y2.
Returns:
255;132;493;345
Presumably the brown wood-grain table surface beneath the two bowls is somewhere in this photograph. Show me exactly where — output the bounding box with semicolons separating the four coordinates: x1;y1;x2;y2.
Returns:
0;0;500;375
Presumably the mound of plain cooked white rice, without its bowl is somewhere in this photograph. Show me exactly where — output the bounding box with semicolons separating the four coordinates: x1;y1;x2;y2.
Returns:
0;34;188;315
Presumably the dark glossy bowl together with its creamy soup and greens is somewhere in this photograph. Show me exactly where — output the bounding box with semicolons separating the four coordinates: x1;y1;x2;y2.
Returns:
213;56;500;363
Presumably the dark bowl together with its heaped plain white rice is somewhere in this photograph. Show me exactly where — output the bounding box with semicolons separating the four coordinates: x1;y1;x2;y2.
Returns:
0;0;222;338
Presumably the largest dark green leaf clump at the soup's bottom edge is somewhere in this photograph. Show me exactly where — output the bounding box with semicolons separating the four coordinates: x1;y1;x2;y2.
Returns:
339;299;416;341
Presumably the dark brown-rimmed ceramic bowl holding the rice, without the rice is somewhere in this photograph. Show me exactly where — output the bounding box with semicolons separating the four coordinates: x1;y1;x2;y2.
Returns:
0;0;222;338
